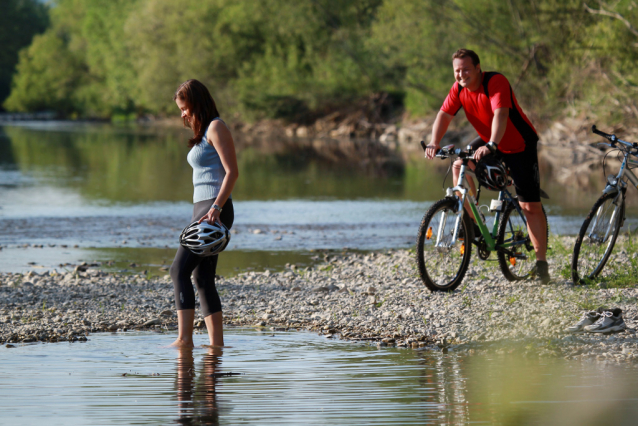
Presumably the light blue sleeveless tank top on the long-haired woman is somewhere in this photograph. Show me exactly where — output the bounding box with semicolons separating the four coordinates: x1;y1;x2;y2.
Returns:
186;117;231;203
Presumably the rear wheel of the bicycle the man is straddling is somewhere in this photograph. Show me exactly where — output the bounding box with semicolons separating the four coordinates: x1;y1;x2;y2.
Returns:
496;200;549;281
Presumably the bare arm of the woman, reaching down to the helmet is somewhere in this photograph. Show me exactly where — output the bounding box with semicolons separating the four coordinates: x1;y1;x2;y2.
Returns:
199;120;239;223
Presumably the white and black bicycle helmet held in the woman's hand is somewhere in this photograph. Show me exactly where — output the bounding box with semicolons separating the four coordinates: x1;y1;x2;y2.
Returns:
179;221;230;257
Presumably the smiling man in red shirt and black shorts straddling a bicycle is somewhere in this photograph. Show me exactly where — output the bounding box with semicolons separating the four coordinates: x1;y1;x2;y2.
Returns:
425;49;550;284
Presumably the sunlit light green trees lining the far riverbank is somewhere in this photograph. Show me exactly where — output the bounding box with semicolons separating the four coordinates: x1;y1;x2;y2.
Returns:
4;0;638;124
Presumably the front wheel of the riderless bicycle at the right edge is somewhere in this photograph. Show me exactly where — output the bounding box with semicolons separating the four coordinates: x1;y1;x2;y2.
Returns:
572;194;625;284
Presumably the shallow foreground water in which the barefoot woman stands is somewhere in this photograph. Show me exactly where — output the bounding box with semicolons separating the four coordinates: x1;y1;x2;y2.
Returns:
0;329;638;425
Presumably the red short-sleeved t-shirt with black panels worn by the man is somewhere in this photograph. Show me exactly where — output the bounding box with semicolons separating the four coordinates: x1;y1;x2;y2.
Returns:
441;72;538;154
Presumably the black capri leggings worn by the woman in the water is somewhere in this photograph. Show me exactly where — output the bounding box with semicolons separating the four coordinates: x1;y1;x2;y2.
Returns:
170;199;235;317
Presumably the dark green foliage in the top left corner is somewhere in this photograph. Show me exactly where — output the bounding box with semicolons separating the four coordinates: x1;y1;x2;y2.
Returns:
0;0;49;110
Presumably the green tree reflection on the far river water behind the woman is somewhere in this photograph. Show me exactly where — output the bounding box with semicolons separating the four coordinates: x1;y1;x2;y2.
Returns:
0;125;425;203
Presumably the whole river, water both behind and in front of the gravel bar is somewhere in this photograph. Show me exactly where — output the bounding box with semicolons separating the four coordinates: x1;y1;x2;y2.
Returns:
0;122;638;425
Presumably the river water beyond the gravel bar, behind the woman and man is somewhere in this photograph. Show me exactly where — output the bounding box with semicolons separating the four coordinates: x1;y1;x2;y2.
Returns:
0;122;638;273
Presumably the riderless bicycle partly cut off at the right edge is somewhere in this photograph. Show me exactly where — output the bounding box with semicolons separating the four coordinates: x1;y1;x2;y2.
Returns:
571;126;638;284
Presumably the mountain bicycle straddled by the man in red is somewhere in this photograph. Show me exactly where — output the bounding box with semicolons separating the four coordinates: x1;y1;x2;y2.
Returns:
417;141;549;291
